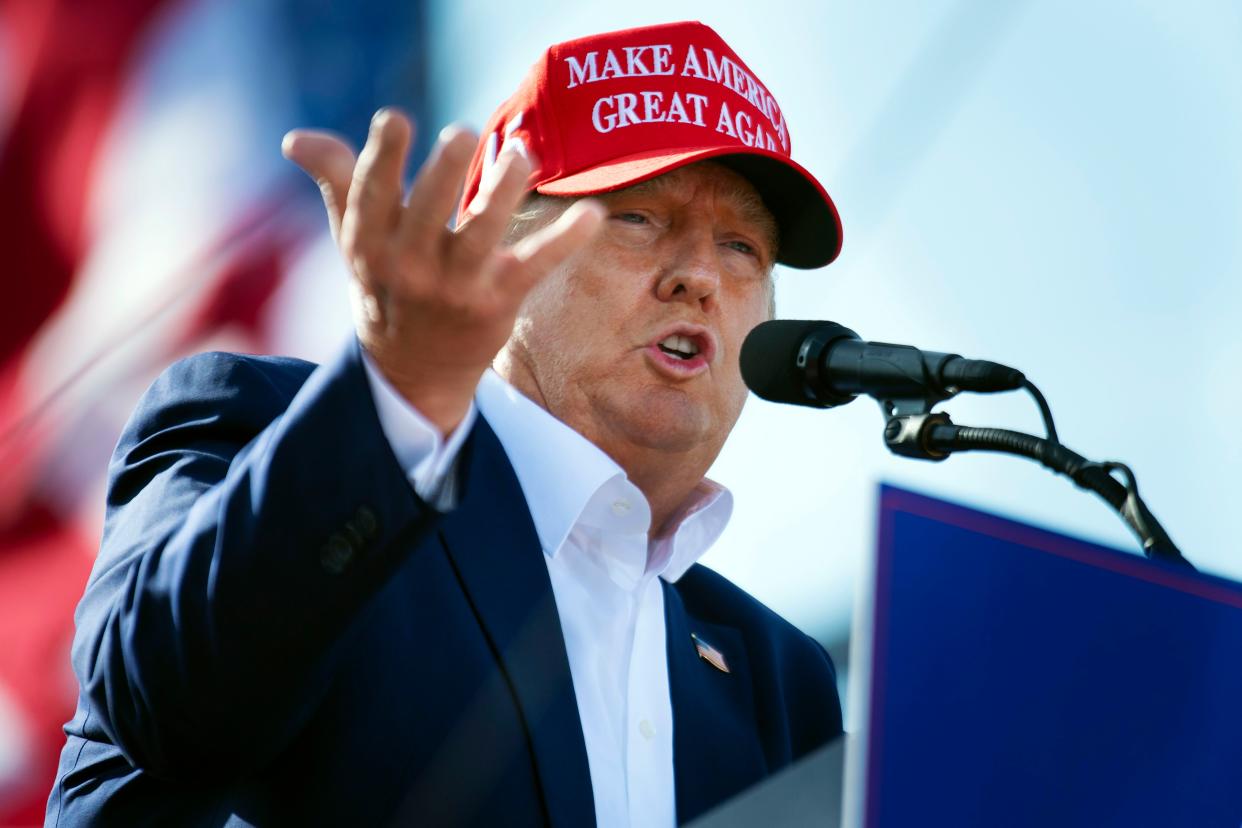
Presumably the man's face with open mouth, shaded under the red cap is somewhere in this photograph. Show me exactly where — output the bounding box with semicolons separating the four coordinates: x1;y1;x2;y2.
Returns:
496;163;776;463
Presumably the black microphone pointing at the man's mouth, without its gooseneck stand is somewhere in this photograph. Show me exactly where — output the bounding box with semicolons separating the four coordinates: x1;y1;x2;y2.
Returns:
741;319;1026;408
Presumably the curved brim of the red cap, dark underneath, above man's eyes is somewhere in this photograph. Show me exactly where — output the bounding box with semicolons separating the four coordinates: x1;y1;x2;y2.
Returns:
535;144;841;269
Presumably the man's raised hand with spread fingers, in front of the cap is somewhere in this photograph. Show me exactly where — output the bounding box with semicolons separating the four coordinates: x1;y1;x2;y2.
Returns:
283;109;604;433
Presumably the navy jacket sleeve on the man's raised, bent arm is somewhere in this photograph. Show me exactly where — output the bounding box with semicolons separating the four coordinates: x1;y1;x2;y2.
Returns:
73;341;438;780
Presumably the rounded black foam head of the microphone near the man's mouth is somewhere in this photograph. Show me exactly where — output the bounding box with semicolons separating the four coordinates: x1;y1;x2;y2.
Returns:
740;319;858;408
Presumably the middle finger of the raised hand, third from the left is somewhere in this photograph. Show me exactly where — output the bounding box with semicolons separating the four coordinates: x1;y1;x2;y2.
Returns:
401;125;477;251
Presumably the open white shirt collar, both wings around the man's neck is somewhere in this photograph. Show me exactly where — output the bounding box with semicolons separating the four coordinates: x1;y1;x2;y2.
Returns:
474;370;733;581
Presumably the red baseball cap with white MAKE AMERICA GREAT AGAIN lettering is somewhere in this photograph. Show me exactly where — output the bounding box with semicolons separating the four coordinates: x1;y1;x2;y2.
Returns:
458;21;841;268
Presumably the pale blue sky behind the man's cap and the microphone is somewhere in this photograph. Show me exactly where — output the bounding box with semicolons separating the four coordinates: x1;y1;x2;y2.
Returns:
419;0;1242;655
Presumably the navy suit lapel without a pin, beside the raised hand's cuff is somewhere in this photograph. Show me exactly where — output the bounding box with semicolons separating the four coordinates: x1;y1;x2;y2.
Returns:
441;417;595;827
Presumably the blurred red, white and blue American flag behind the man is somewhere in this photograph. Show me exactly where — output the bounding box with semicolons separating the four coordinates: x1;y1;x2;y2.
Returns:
0;0;433;826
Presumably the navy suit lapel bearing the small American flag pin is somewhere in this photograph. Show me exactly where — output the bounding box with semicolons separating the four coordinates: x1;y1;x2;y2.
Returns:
661;582;768;823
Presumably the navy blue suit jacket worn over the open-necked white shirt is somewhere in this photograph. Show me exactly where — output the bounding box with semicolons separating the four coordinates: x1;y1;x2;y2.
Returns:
47;344;841;827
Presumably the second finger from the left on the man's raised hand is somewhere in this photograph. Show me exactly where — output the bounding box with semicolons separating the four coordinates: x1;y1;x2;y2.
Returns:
342;109;414;257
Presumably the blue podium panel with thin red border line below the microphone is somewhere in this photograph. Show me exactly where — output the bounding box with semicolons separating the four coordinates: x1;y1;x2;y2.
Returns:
863;487;1242;828
